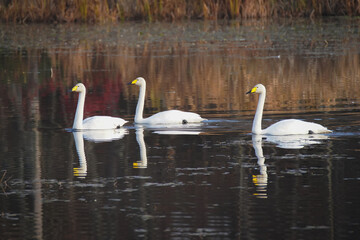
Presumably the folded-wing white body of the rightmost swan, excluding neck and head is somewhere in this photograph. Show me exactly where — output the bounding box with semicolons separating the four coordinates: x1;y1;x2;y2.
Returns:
263;119;331;135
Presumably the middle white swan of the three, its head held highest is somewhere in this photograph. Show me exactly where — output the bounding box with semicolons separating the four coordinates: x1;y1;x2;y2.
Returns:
129;77;206;124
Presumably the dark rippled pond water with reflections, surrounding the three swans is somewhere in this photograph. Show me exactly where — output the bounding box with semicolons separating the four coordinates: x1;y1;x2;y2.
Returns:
0;18;360;239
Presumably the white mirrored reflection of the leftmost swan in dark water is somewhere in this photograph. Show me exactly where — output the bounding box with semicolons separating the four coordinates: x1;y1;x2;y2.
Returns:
72;129;128;178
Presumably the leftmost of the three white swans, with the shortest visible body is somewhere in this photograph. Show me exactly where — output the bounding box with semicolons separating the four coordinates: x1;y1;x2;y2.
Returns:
71;83;127;130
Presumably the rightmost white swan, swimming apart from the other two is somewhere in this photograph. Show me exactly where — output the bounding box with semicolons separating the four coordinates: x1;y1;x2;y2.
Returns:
246;84;332;135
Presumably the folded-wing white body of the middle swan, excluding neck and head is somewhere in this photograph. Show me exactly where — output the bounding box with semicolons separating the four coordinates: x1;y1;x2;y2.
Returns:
143;110;206;124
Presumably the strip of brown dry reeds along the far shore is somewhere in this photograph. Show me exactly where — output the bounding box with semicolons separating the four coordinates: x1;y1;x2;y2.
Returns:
0;0;360;23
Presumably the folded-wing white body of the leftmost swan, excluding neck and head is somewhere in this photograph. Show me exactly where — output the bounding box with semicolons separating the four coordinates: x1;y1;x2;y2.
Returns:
83;116;127;130
